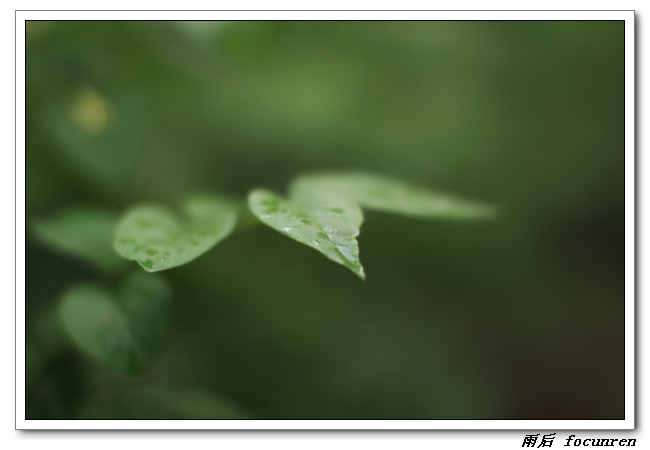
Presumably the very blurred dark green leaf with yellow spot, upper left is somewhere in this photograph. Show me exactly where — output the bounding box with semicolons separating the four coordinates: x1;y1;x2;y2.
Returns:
45;86;143;192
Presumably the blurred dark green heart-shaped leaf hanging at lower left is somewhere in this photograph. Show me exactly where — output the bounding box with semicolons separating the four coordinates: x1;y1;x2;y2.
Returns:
60;272;171;375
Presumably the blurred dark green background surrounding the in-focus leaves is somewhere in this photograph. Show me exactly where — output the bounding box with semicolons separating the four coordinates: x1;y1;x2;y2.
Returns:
25;21;625;419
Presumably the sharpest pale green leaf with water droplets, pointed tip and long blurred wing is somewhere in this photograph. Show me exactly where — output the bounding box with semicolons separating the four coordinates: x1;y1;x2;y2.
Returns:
248;174;495;280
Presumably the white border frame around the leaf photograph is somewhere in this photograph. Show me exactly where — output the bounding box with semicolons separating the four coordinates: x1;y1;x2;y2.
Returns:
15;10;636;431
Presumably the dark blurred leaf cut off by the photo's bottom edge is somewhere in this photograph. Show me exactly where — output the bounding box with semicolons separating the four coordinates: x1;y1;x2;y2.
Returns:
80;386;251;420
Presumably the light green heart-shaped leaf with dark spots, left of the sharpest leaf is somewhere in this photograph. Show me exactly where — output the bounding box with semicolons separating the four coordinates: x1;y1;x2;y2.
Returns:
114;197;237;272
